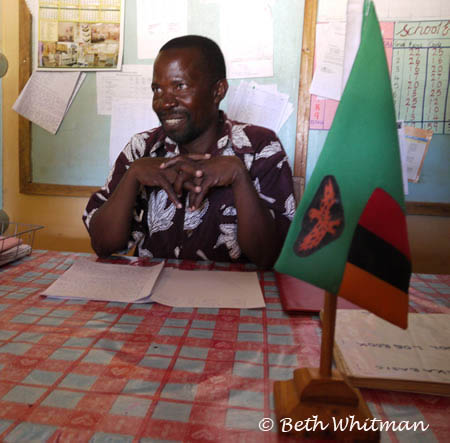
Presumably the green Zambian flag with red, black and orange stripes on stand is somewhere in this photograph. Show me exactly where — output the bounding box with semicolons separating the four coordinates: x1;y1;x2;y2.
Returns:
275;2;411;328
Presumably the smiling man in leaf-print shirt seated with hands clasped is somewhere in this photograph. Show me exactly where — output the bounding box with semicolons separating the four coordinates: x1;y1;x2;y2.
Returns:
83;35;295;268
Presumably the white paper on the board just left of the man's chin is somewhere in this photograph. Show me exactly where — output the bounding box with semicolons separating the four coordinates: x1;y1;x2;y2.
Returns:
109;99;159;166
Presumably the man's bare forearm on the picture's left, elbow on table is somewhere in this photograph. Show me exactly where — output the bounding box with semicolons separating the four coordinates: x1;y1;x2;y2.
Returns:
89;171;139;257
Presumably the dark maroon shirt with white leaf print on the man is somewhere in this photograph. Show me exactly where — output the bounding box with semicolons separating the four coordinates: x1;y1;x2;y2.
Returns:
83;113;295;262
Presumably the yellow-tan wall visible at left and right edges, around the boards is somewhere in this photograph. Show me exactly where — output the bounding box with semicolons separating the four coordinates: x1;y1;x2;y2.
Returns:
0;0;450;274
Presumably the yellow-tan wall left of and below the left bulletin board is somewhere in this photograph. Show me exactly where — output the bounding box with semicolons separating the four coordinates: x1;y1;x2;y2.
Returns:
0;0;90;251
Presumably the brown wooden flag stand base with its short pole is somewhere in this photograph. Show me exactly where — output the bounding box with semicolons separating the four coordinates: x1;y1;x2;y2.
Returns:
274;292;380;441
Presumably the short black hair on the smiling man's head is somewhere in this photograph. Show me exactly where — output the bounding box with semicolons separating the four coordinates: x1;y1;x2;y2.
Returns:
159;35;227;82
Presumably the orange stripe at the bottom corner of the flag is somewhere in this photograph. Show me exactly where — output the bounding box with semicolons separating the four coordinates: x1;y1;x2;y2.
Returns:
337;262;408;329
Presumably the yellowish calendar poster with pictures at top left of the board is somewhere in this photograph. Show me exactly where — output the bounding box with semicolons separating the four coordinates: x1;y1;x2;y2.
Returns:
35;0;124;71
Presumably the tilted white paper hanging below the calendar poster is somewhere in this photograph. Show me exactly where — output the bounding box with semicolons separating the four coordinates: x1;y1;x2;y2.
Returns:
13;71;84;134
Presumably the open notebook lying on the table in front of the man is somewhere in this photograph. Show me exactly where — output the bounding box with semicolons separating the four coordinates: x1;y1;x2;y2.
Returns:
41;258;265;309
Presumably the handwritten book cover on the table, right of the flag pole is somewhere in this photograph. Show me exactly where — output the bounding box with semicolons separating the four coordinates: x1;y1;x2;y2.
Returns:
335;309;450;395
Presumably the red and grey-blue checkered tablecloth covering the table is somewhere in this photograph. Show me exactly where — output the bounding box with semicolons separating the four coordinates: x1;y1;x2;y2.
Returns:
0;250;450;443
